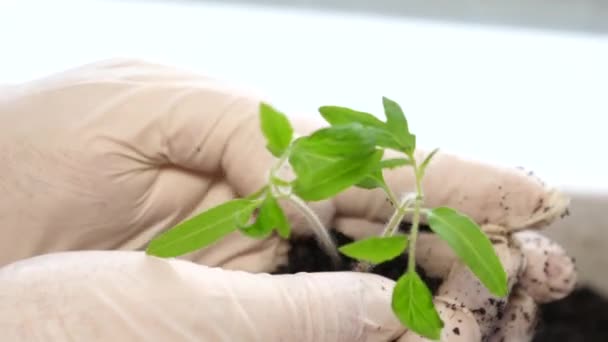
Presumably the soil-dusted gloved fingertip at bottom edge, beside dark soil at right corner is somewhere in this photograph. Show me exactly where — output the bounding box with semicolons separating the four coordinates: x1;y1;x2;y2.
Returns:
488;288;539;342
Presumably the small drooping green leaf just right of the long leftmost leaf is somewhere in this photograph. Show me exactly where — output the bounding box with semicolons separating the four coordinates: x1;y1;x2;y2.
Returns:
241;194;291;239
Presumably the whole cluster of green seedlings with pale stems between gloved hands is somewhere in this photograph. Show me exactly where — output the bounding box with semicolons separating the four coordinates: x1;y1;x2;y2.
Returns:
146;97;508;340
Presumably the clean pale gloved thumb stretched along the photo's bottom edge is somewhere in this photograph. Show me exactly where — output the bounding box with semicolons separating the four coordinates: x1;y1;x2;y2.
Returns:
0;251;405;342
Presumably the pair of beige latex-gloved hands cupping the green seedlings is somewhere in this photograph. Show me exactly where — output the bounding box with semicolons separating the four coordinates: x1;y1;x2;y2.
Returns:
0;60;575;342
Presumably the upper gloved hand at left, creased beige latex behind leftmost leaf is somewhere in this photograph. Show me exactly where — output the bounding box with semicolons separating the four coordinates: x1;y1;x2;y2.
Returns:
0;60;298;271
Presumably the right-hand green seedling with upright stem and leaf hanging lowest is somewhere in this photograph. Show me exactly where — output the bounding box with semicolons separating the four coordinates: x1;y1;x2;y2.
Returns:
328;97;508;339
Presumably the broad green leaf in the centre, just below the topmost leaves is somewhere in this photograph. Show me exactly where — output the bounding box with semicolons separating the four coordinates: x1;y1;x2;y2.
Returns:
290;151;383;201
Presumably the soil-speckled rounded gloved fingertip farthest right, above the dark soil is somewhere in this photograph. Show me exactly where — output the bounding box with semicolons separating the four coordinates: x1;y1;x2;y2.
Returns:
513;231;577;303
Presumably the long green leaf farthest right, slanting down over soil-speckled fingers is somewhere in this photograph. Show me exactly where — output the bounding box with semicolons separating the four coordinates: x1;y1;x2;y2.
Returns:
427;207;508;297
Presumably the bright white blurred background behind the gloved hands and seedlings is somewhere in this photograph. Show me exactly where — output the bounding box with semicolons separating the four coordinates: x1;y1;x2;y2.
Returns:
0;0;608;293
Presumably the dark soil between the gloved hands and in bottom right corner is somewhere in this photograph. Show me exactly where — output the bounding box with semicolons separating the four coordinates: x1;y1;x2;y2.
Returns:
276;227;608;342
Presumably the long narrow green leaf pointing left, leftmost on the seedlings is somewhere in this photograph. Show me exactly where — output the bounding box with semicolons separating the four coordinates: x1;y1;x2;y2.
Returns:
146;199;256;257
